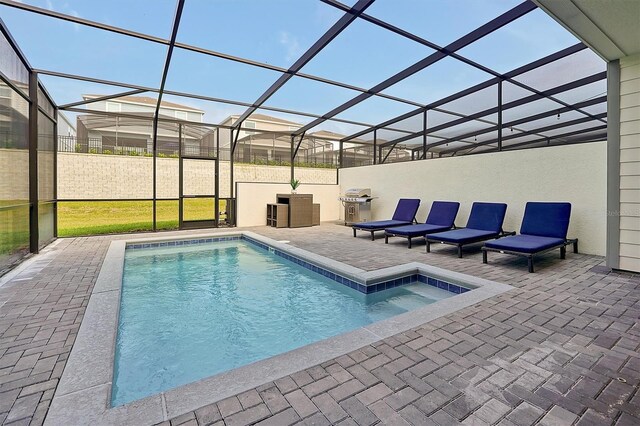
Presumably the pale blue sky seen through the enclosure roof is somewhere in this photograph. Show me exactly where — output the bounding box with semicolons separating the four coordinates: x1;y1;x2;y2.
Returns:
0;0;604;134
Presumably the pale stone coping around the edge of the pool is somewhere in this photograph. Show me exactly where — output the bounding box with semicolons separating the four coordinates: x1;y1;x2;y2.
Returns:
45;230;513;425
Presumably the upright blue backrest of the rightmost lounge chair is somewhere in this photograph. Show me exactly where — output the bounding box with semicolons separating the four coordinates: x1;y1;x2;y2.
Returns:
520;202;571;239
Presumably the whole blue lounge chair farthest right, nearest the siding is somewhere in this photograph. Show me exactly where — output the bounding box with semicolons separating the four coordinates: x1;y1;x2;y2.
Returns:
482;202;578;272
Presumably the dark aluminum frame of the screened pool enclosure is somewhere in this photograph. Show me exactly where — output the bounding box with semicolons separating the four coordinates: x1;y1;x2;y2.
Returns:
0;0;607;252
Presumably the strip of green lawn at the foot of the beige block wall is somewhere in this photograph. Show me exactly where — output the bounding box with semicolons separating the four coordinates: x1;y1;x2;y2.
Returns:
58;198;226;237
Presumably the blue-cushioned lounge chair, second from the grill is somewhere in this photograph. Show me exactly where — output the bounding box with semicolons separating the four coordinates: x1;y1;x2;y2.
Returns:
384;201;460;248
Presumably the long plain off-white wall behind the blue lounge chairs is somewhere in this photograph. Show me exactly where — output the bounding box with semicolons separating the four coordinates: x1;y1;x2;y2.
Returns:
340;142;606;255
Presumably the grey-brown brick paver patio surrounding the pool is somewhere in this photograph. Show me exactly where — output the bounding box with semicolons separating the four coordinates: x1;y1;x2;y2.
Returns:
0;225;640;425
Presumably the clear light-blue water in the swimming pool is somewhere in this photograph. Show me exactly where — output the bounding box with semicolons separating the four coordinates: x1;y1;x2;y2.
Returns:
111;240;453;406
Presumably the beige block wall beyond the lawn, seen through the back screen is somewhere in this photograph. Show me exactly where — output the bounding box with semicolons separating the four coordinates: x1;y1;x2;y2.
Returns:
56;153;336;199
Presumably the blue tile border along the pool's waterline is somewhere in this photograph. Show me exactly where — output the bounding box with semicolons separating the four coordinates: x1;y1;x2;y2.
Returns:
126;234;472;294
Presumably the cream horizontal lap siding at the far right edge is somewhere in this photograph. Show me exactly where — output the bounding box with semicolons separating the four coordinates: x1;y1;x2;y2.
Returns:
619;55;640;272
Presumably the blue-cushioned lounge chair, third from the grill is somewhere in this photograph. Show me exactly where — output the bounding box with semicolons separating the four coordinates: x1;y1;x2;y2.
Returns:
426;203;515;257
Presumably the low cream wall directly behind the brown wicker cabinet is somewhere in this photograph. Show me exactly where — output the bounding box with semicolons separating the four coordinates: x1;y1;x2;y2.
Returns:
236;185;341;226
